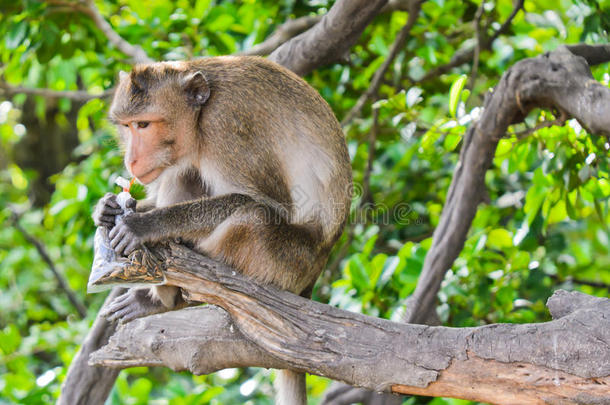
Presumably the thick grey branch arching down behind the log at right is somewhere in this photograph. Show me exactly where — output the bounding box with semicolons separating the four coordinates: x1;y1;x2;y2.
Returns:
405;48;610;323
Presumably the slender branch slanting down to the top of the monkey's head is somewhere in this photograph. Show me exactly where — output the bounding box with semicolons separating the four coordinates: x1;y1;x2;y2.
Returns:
48;0;154;63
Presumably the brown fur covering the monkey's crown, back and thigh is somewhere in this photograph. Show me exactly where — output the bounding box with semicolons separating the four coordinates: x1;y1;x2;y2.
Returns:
110;57;351;293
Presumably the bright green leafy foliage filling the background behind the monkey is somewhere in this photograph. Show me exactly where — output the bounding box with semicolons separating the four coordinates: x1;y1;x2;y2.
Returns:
0;0;610;404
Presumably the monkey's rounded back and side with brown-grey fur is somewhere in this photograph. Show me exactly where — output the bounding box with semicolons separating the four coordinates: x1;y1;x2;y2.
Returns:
191;56;351;245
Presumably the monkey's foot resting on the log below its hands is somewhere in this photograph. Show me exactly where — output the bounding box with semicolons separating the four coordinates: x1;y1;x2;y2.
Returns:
100;288;168;323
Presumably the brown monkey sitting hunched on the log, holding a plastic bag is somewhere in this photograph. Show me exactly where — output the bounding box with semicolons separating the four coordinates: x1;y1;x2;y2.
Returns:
93;56;352;405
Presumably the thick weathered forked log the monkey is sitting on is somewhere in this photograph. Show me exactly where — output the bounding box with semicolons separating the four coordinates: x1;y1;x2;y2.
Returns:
91;244;610;404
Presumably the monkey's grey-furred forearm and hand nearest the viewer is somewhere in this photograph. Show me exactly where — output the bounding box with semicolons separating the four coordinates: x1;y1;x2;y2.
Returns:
108;194;254;255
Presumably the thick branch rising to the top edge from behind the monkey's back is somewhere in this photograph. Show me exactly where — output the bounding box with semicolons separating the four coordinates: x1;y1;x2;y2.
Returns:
269;0;387;76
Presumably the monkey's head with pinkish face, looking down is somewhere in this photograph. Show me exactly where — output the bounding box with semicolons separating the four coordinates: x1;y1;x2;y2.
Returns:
109;62;210;184
